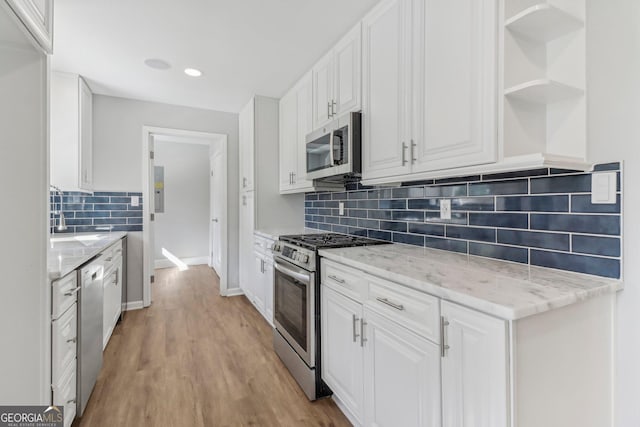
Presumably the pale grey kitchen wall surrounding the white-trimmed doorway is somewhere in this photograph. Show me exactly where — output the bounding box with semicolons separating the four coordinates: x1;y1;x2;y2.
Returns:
93;95;239;301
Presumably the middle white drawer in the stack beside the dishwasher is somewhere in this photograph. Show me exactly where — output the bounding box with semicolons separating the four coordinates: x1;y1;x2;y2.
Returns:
51;304;78;384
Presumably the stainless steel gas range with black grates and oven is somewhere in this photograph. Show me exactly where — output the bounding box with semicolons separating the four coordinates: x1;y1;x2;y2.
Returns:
271;233;389;400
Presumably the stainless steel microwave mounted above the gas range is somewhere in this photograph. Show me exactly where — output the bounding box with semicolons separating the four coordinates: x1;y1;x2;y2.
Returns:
305;113;362;179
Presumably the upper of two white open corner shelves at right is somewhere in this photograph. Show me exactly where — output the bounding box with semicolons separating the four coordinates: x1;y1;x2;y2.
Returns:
504;3;584;43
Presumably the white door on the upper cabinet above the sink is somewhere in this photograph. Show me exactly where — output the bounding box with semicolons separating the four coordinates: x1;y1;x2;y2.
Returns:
78;77;93;190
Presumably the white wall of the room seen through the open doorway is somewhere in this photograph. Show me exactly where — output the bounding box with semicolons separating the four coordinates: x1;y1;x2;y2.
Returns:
154;141;209;261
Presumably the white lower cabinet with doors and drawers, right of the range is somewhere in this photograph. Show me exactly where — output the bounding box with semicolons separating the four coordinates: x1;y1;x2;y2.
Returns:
321;260;508;427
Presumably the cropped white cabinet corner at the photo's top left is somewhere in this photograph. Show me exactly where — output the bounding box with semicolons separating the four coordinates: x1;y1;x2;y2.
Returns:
6;0;53;54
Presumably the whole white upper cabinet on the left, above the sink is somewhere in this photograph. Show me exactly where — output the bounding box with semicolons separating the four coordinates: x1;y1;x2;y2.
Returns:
50;72;93;191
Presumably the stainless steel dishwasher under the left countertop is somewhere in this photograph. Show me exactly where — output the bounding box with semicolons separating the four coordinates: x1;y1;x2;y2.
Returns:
77;257;104;416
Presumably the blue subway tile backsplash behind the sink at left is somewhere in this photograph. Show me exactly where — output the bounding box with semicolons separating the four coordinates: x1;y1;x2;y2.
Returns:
49;191;142;233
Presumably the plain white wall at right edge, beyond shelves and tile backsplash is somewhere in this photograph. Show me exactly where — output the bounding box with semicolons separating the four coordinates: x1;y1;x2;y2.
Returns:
587;0;640;427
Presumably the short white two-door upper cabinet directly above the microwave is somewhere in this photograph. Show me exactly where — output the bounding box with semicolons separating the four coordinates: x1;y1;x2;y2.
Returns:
312;23;362;129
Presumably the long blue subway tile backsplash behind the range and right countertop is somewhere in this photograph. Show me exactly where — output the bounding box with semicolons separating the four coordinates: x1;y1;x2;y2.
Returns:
305;163;622;278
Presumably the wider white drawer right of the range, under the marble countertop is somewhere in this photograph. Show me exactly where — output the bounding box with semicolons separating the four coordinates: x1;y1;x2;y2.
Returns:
366;277;440;343
